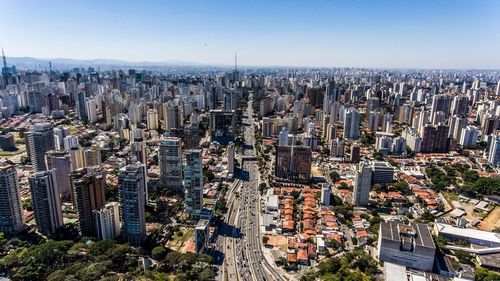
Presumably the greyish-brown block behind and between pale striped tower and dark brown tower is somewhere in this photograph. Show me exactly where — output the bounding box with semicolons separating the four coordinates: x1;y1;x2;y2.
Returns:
45;150;73;199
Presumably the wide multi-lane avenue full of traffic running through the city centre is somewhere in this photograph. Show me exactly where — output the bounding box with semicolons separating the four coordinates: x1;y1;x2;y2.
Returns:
221;91;285;281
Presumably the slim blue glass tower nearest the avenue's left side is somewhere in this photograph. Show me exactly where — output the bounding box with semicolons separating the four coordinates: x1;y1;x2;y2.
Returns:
183;149;203;220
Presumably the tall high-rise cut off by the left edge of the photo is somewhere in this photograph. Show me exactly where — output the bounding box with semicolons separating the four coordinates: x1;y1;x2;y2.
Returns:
0;163;24;235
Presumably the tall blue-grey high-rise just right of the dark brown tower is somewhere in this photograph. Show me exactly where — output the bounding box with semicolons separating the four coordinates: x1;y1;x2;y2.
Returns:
118;163;146;245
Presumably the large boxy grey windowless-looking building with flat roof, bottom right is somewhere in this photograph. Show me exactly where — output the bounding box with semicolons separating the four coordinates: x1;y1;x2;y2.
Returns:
378;220;436;272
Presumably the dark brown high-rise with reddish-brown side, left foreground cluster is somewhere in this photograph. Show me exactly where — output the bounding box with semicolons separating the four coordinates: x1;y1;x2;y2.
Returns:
71;167;106;237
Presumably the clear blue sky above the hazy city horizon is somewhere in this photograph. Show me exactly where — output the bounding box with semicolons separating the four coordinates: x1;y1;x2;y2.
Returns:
0;0;500;69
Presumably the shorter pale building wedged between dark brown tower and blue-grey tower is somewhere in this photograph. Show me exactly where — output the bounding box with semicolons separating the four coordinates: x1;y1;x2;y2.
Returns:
92;202;121;240
